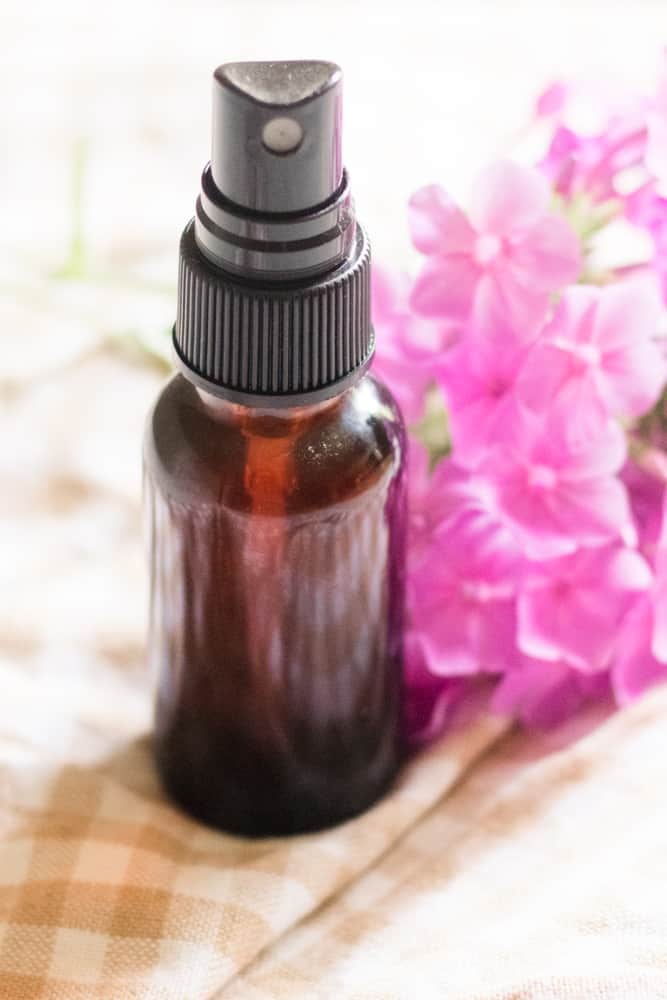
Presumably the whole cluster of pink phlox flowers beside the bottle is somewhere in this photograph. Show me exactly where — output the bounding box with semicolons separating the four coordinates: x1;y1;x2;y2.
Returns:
373;62;667;739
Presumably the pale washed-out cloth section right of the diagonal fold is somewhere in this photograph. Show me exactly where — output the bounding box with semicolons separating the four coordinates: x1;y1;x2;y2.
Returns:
219;689;667;1000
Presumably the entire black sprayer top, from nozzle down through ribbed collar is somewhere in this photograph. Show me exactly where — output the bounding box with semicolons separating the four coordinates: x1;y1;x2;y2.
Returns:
174;61;373;405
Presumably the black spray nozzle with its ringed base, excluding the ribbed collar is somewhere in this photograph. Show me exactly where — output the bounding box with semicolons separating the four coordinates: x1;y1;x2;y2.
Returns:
195;61;355;279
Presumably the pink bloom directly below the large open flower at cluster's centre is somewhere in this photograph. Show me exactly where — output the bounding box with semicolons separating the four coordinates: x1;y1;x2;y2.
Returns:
517;546;652;672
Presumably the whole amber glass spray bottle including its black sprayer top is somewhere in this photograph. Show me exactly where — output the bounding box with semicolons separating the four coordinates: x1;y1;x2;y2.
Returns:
145;63;405;835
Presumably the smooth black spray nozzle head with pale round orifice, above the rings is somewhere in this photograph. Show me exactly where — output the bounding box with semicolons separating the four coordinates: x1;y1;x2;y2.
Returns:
211;62;343;213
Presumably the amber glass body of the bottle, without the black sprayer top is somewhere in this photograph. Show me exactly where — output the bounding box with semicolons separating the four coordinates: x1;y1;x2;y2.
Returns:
144;375;406;835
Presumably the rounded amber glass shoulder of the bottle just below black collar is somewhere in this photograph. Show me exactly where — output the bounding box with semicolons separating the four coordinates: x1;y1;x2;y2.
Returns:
144;374;405;514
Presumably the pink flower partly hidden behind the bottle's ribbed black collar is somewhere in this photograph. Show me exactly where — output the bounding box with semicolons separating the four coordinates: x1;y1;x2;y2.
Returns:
371;266;452;423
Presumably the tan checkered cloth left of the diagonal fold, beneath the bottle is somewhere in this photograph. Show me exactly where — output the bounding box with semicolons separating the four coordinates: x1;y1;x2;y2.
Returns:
0;648;502;1000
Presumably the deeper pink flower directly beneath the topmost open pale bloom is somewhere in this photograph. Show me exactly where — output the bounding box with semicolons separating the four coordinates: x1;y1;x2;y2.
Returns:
436;292;527;468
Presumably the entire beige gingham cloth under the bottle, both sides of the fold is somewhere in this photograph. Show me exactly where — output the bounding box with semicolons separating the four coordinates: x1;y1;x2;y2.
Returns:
0;636;667;1000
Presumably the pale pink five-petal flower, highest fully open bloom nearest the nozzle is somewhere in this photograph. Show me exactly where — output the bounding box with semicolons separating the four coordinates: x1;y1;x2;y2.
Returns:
410;162;580;328
